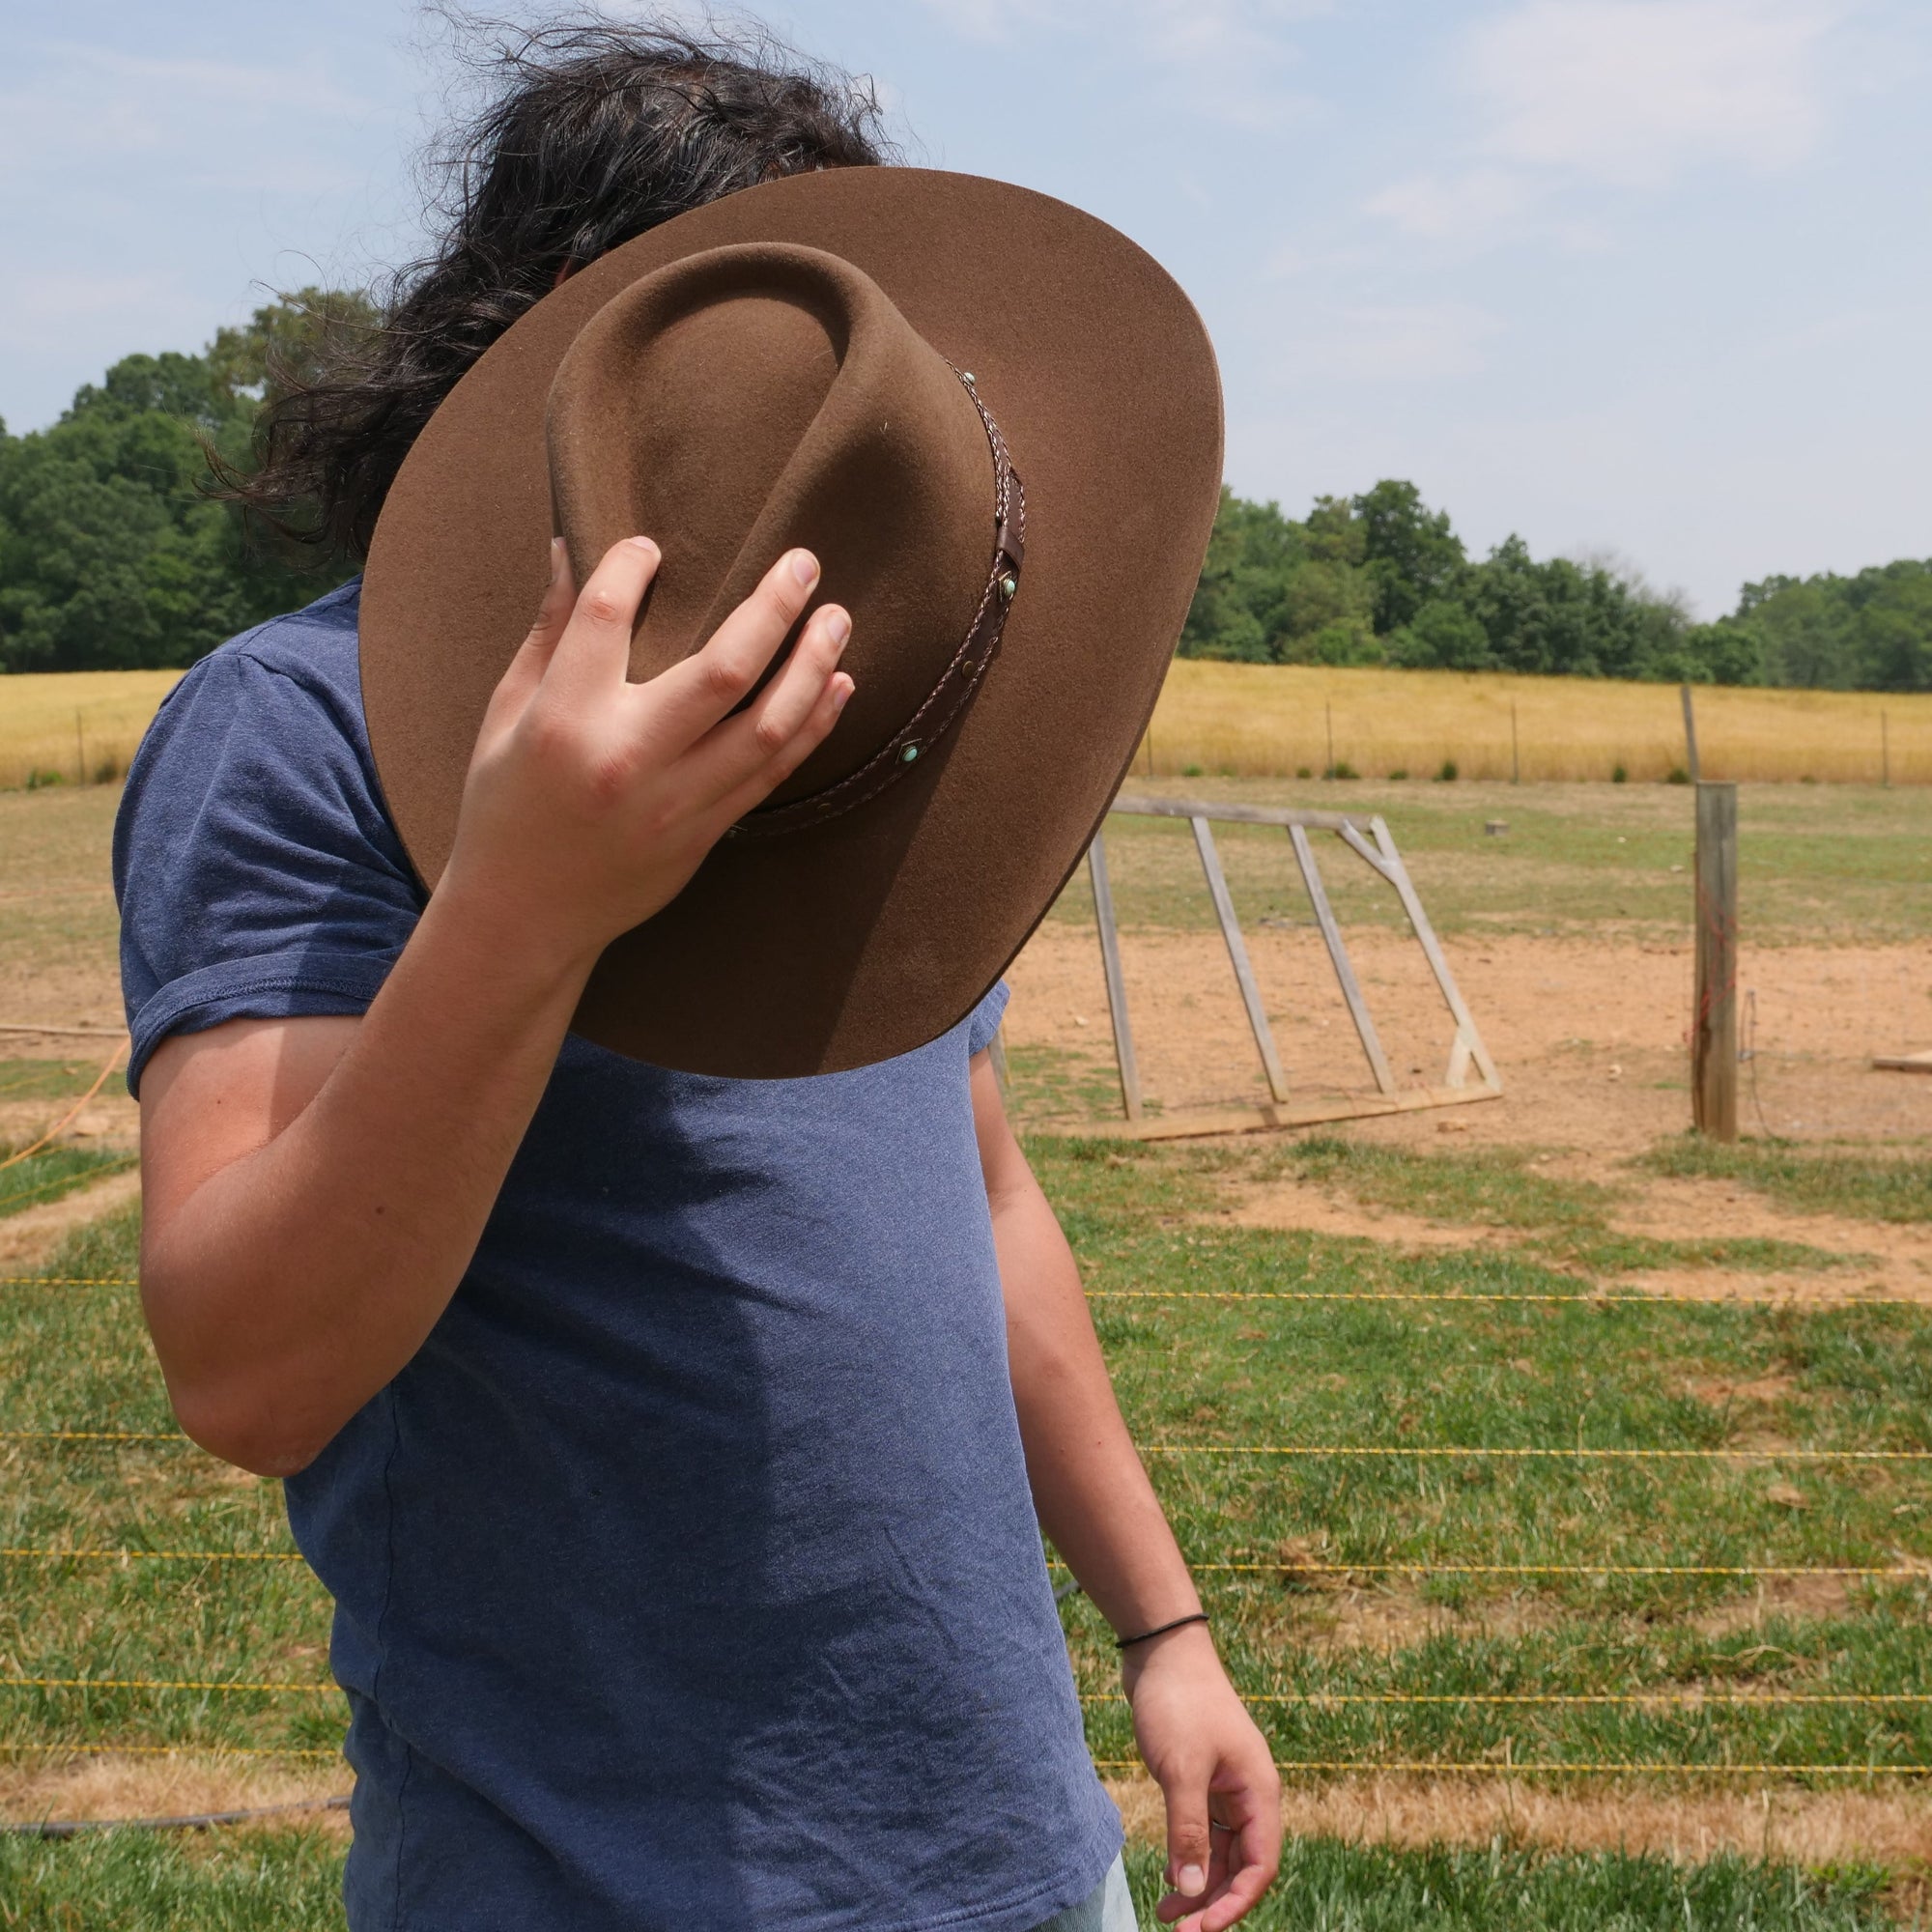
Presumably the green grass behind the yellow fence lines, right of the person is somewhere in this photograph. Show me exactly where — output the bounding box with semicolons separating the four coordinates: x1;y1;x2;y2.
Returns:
1032;1142;1932;1768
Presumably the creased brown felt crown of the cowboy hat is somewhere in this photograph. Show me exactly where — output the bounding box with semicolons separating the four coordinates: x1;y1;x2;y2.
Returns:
545;243;997;804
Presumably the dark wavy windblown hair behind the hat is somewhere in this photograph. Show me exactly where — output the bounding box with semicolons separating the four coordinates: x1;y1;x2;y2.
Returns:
218;15;895;566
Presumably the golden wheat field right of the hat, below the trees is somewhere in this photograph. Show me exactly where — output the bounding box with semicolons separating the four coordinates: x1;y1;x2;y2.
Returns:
1136;661;1932;784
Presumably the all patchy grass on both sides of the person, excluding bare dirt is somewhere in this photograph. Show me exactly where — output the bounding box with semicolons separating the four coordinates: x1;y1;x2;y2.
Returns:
0;781;1932;1932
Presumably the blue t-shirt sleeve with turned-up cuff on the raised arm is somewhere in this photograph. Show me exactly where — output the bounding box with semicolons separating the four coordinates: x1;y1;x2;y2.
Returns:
114;585;421;1092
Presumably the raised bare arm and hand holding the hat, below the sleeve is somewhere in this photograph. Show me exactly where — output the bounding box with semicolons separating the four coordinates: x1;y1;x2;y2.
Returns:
141;537;852;1476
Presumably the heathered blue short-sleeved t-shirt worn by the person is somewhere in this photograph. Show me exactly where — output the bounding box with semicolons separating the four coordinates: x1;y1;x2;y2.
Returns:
114;585;1121;1932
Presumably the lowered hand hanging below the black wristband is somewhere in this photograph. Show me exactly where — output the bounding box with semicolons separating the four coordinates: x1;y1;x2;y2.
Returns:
1121;1623;1281;1932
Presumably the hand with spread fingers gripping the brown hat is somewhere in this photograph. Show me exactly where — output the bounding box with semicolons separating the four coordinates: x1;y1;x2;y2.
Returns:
448;537;852;972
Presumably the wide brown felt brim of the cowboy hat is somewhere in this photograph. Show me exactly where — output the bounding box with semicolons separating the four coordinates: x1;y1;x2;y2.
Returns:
361;168;1221;1078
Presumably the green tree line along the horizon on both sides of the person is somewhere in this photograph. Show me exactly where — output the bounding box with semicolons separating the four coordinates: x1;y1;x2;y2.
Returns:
0;288;1932;692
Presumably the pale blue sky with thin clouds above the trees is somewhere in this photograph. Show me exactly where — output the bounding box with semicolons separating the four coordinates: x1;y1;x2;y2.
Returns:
0;0;1932;616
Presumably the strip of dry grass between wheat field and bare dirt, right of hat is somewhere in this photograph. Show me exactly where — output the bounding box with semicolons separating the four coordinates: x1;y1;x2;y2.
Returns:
1053;779;1932;943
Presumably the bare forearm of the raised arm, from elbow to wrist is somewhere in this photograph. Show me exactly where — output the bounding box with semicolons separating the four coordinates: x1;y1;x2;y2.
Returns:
143;895;583;1474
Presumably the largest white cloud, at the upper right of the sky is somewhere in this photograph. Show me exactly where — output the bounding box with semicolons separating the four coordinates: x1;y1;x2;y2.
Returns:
1366;0;1843;247
